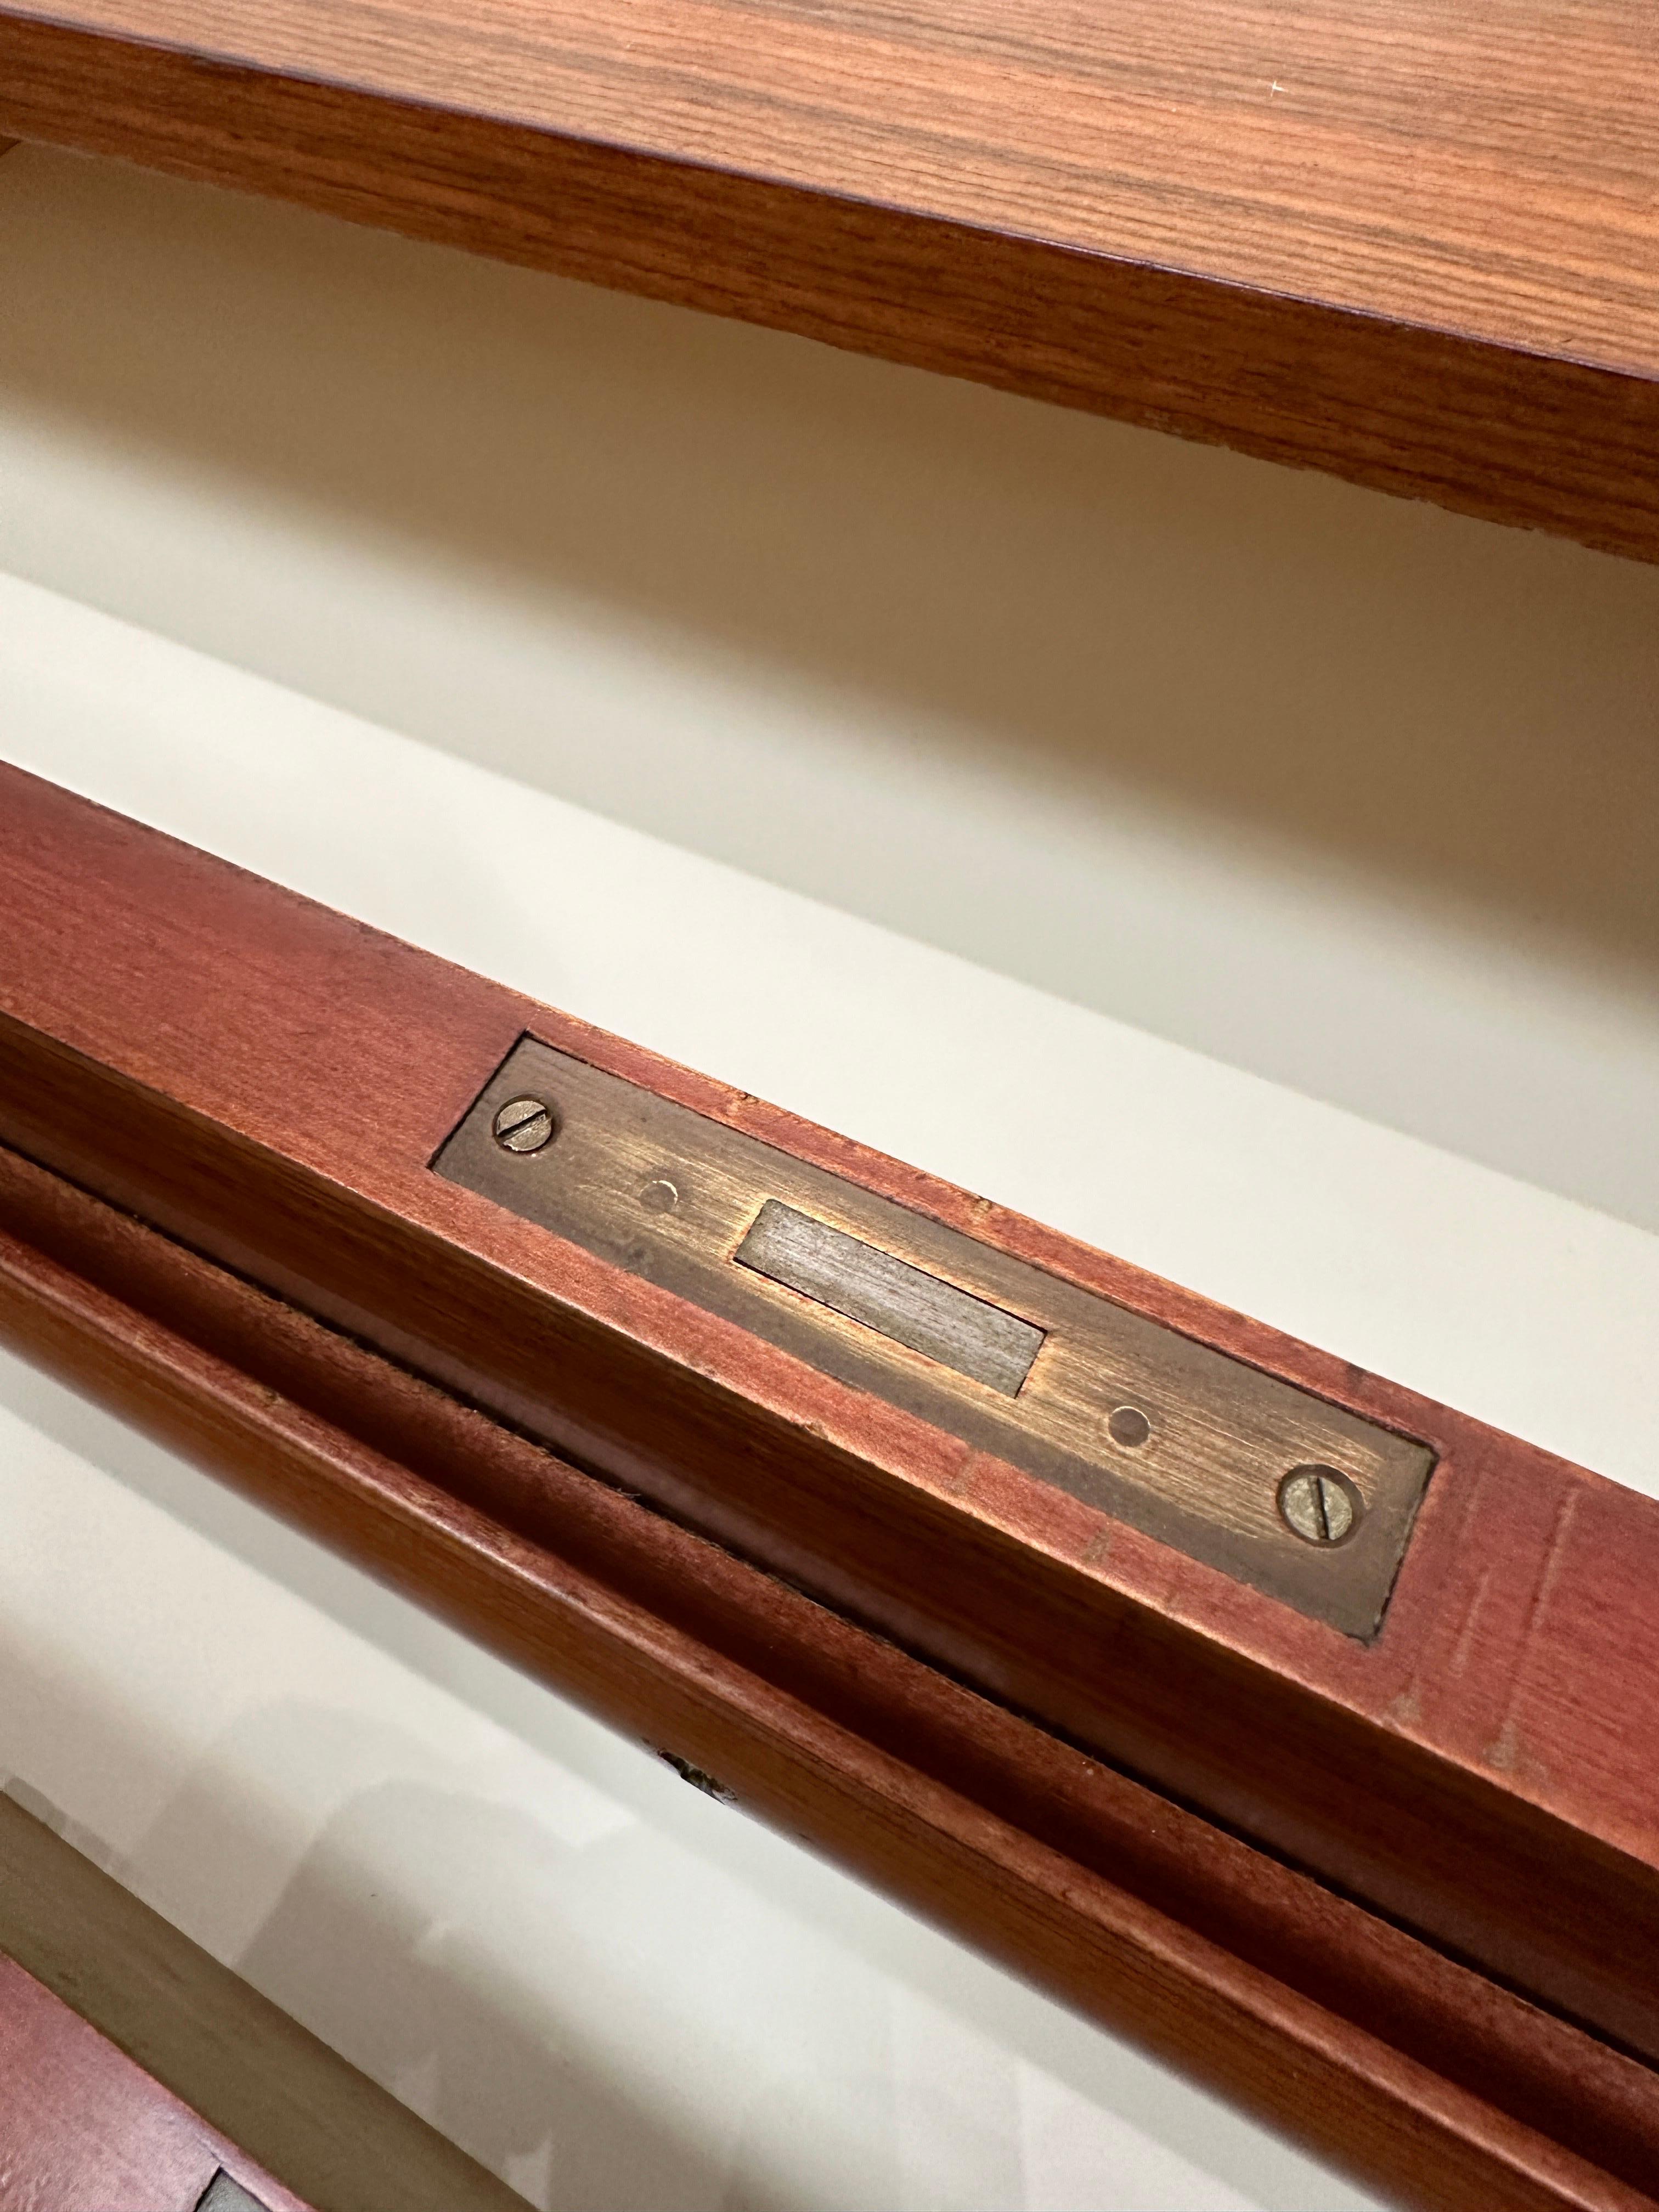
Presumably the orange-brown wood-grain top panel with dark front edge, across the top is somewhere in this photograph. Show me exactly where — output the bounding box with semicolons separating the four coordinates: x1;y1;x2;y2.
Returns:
0;0;1659;560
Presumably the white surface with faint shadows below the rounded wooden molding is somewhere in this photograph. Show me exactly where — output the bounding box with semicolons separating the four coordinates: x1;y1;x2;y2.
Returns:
0;1363;1367;2212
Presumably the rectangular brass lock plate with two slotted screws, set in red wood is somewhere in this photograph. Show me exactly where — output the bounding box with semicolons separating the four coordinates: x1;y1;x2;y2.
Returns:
433;1037;1434;1639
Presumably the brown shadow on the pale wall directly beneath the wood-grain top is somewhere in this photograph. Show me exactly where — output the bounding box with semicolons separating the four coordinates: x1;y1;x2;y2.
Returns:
0;138;1659;978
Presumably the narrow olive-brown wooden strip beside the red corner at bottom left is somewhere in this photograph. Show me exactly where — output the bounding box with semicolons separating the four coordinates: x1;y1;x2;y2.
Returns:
0;1787;524;2212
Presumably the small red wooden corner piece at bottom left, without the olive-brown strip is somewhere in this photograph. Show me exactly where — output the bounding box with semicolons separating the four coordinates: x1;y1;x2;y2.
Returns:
0;1953;305;2212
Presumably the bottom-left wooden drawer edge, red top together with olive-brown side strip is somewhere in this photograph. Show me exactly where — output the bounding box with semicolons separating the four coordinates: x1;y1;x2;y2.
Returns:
0;1785;522;2212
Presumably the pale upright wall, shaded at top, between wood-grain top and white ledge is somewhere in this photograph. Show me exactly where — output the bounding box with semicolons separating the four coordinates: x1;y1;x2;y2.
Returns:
0;148;1659;1228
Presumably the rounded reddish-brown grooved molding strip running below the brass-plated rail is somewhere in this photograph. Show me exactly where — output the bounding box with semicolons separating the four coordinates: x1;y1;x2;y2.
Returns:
0;1153;1659;2212
